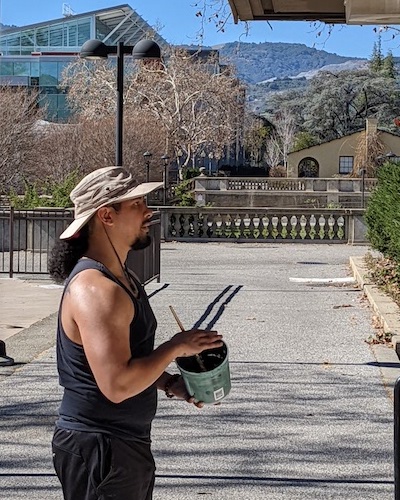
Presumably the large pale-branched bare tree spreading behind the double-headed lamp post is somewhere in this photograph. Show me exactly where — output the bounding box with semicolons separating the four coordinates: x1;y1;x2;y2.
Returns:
63;51;244;178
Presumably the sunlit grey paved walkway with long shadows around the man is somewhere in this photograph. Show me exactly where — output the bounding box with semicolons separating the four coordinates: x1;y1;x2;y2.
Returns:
0;243;400;500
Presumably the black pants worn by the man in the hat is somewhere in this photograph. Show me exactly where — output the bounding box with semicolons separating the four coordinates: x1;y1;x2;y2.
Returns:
52;428;155;500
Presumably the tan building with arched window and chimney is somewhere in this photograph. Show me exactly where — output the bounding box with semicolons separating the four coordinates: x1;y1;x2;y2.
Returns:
287;119;400;178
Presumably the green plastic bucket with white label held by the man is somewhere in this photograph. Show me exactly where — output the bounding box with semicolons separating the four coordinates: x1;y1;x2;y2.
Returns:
176;343;231;404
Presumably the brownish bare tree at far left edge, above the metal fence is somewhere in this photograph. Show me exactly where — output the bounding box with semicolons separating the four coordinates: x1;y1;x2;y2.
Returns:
0;86;43;192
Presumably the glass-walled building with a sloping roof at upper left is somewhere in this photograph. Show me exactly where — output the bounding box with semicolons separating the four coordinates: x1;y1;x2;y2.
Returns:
0;4;168;121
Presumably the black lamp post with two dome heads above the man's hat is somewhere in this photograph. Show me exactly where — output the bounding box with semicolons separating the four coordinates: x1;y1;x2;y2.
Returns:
80;39;161;166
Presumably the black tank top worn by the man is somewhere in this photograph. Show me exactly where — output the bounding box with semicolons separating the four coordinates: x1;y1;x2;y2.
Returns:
57;259;157;442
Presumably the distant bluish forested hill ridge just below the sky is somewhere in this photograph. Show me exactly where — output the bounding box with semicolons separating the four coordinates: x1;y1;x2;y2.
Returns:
214;42;362;84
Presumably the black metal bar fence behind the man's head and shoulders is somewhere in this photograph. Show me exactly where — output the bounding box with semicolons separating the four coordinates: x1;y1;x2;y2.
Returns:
0;207;161;283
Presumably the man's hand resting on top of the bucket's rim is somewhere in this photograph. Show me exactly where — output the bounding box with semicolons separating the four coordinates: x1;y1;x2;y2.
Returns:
170;330;223;358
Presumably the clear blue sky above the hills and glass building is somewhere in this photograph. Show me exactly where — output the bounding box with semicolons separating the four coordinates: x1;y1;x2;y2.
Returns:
0;0;400;58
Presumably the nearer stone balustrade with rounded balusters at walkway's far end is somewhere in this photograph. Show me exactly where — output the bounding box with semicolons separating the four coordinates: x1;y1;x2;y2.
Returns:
161;207;366;243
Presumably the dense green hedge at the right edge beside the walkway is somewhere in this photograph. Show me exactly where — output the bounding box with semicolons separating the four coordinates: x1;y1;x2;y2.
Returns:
365;162;400;264
